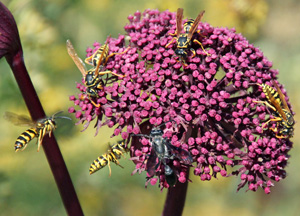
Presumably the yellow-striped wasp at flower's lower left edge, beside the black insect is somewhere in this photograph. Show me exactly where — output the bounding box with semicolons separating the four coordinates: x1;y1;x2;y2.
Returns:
90;140;128;176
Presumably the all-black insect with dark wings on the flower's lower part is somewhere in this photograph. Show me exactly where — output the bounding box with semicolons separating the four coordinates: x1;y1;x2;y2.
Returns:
134;124;193;186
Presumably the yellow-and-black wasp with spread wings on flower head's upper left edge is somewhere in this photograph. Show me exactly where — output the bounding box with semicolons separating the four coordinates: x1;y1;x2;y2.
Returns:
67;37;129;107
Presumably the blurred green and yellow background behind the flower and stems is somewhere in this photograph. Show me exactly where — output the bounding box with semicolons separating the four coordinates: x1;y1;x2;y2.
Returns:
0;0;300;216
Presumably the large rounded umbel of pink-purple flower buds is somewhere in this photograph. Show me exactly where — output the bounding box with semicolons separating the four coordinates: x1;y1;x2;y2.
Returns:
69;10;292;193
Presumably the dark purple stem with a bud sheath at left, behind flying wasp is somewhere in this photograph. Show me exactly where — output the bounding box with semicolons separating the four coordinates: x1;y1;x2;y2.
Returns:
0;2;83;215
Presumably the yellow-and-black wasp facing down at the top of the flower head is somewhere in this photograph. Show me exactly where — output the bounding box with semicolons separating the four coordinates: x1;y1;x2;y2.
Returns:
165;8;209;63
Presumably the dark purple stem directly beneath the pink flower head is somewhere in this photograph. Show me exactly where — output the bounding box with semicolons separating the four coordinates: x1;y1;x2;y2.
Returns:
162;170;189;216
